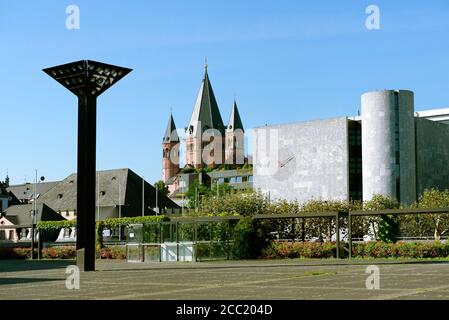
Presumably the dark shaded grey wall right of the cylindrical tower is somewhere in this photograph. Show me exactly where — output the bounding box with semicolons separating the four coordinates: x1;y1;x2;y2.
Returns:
416;118;449;195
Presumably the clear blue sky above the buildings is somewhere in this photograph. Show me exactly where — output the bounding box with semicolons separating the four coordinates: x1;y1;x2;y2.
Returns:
0;0;449;183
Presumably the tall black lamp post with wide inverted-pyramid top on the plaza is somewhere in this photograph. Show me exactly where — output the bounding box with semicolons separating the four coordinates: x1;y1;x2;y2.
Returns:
43;60;131;271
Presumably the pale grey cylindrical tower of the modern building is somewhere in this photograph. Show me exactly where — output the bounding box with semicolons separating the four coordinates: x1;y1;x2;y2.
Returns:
362;90;416;204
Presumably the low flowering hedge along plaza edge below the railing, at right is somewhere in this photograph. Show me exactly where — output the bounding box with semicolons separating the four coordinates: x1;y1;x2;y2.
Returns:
262;241;449;259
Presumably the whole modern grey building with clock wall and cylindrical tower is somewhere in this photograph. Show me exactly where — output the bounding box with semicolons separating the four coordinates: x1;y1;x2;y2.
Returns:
253;90;449;203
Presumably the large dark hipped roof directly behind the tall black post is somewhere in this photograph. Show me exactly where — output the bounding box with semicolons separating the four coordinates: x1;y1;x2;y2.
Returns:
38;169;178;213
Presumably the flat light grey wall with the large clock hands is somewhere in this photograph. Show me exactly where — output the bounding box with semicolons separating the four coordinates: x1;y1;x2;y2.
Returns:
253;118;349;202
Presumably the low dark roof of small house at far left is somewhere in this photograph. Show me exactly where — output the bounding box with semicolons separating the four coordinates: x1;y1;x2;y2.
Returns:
5;203;65;225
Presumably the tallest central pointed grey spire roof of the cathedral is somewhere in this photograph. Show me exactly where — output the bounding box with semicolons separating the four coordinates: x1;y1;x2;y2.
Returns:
186;66;225;137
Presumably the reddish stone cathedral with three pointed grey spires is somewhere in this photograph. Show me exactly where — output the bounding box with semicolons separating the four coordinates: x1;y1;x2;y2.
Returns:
162;64;246;189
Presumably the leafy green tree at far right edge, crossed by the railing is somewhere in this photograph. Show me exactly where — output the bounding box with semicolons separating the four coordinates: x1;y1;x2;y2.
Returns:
418;188;449;241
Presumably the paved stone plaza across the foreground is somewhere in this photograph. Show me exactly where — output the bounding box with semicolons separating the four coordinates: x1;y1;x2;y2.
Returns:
0;259;449;300
